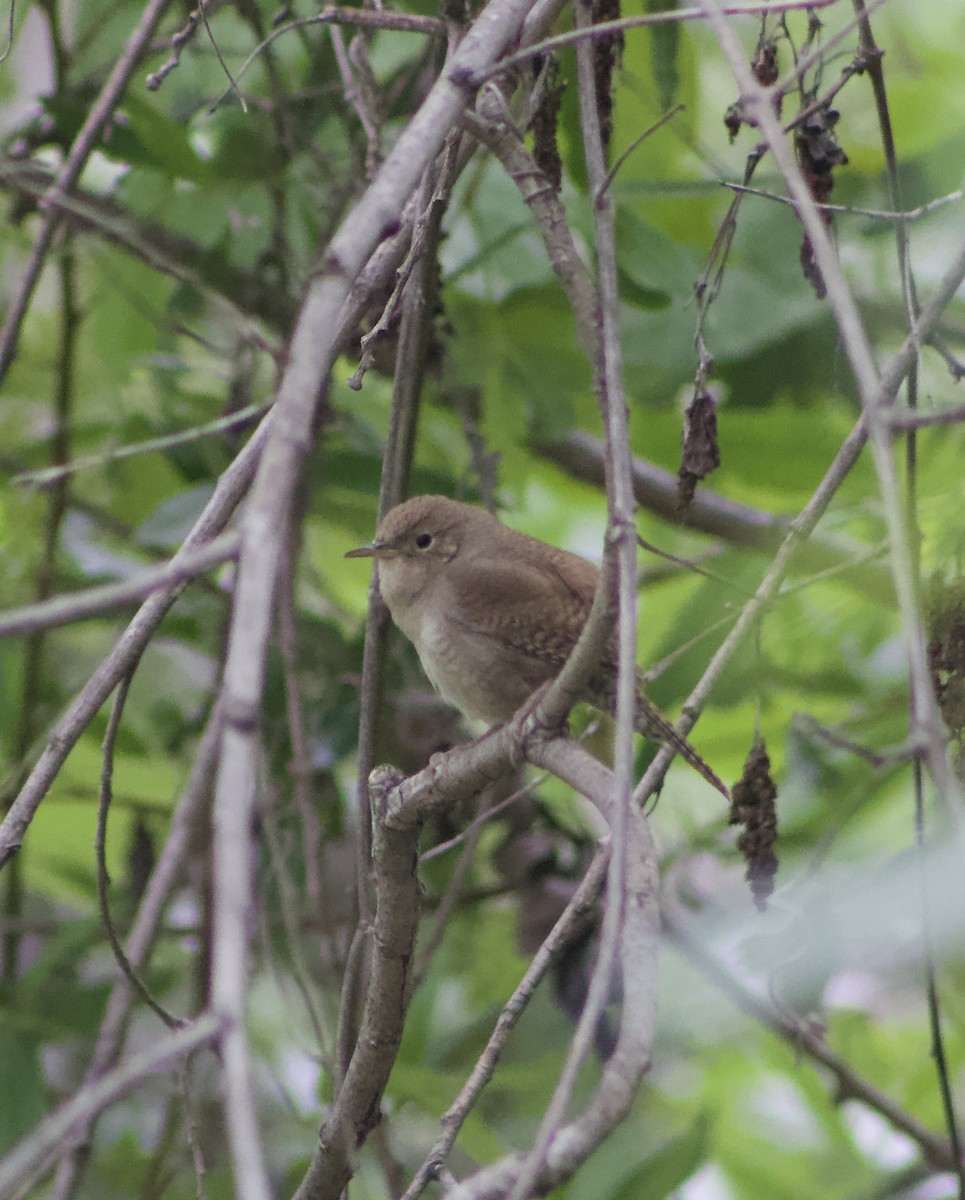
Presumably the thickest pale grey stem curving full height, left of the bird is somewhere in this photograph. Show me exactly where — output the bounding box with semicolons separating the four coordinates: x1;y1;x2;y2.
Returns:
212;0;542;1200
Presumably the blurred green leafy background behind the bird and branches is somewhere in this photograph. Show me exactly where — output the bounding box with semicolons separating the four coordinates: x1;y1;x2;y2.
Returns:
0;0;965;1200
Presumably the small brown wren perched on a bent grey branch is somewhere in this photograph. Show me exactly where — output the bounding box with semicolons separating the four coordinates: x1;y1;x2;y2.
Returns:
346;496;729;796
